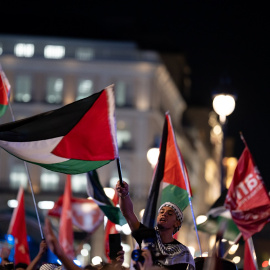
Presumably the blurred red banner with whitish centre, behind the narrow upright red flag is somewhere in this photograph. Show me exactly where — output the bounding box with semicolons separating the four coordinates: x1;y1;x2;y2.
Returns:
48;193;104;233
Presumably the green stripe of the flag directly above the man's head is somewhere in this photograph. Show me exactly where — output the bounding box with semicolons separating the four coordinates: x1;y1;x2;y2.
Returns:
161;185;189;211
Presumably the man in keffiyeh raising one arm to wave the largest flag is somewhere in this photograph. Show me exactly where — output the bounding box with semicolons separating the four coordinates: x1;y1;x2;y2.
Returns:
116;181;195;270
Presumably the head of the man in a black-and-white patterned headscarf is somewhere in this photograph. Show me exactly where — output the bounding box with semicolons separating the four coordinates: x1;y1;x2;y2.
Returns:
157;202;183;234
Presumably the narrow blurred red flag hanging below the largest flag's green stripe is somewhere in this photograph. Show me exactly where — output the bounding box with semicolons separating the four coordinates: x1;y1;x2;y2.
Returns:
59;175;74;259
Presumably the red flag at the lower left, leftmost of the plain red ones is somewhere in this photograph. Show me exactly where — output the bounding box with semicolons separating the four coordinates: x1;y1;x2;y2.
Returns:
8;187;30;265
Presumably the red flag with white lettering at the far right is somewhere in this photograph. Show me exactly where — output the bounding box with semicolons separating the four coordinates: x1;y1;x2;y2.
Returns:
225;141;270;240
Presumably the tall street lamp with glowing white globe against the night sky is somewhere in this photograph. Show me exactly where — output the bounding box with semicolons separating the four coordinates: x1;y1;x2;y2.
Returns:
213;93;235;193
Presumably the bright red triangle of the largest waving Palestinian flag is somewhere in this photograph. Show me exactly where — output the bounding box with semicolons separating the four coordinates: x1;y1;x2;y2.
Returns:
52;91;115;161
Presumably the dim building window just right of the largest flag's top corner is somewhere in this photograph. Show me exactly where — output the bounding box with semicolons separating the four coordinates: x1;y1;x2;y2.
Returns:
115;81;133;107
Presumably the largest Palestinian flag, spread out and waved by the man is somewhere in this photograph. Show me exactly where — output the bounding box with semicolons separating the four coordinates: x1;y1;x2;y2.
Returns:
0;85;118;174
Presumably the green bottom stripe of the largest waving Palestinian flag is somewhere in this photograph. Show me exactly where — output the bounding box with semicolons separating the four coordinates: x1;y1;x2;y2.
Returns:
35;159;111;174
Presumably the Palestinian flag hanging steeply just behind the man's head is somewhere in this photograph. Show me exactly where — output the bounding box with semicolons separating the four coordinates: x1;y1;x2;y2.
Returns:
143;113;192;228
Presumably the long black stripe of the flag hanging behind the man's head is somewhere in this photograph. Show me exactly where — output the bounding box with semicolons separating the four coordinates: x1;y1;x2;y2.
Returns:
143;118;168;228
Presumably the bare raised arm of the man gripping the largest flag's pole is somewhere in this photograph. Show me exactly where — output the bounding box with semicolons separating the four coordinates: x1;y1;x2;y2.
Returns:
116;181;140;232
